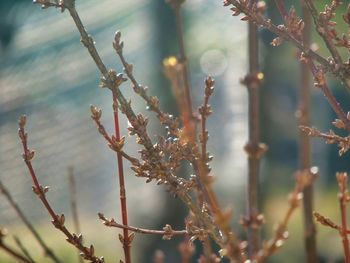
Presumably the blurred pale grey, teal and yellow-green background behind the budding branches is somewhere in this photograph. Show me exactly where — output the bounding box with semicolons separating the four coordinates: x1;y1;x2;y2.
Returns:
0;0;349;263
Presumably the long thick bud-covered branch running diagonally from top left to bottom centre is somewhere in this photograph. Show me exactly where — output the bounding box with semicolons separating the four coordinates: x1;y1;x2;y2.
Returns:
34;0;241;259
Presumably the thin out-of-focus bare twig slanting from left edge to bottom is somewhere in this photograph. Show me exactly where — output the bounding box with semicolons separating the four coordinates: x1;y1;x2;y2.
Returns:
0;180;61;263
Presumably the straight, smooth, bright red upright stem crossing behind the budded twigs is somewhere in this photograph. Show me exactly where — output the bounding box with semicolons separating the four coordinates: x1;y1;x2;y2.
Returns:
112;90;131;263
